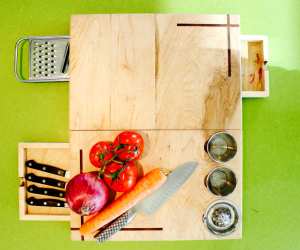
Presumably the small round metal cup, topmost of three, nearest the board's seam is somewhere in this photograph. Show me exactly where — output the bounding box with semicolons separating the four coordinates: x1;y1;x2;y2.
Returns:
204;132;237;163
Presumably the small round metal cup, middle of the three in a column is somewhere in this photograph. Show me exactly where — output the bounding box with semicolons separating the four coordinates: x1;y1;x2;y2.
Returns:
205;166;237;196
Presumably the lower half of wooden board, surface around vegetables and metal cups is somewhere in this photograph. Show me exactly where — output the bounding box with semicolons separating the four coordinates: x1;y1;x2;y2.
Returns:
70;130;242;240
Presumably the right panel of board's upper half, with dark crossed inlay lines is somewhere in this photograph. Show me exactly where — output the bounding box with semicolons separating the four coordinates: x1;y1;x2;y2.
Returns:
156;14;241;129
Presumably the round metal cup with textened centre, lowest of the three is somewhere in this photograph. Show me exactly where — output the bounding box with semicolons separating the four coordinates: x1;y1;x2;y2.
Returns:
203;200;239;236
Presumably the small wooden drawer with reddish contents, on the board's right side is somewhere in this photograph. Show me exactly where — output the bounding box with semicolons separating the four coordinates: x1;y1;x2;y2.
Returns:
240;35;269;97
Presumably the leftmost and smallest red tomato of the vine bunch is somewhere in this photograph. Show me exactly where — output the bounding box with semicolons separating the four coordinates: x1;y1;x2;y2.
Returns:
90;141;114;168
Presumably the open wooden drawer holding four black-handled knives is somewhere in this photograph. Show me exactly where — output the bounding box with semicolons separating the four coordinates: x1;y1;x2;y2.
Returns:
18;143;70;221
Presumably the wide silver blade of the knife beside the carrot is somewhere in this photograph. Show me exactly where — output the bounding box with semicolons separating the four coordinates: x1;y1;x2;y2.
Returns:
134;162;198;214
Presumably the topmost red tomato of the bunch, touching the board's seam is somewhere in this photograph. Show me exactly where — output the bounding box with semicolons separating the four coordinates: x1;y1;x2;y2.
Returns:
114;131;144;161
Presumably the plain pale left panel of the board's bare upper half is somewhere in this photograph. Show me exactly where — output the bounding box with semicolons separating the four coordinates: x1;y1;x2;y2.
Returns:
70;14;155;130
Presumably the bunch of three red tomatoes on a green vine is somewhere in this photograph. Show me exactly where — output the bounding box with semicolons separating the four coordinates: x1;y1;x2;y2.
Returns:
89;131;144;192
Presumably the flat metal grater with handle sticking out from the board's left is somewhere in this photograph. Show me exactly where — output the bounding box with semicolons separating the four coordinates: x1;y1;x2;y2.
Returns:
15;36;69;82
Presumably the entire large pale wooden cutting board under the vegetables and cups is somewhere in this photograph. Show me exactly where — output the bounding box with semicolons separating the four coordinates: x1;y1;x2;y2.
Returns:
70;14;242;240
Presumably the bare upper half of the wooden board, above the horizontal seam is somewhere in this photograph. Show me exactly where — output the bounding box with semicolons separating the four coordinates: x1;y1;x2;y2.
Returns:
70;14;241;130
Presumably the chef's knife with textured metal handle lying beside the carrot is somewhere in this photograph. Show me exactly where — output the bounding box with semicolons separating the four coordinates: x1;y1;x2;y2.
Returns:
95;162;198;243
